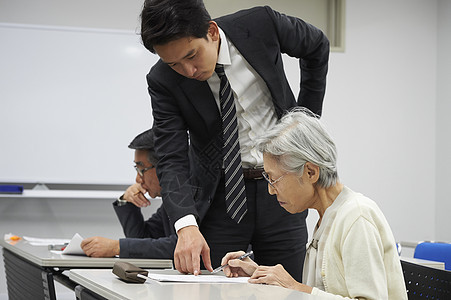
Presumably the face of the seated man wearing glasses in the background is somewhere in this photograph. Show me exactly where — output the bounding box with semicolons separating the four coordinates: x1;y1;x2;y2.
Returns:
135;150;161;198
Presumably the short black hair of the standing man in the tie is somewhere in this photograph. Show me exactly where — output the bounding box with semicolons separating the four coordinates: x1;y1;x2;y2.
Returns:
141;0;211;53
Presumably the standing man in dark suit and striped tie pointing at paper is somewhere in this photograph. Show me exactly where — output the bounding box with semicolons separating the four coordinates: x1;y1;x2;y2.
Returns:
141;0;329;280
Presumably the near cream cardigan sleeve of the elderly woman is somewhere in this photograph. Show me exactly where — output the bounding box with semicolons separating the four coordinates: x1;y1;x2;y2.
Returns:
312;216;388;300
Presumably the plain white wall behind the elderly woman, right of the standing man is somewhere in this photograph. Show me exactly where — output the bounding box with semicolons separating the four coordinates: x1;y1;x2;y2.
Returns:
324;0;440;241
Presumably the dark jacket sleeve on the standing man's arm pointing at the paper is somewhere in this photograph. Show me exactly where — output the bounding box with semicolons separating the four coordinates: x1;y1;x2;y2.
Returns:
147;68;207;224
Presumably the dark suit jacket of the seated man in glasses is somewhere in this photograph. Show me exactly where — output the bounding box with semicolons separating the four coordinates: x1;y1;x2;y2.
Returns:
113;202;177;259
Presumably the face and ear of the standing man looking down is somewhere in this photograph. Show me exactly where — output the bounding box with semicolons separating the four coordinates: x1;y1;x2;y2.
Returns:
154;21;220;81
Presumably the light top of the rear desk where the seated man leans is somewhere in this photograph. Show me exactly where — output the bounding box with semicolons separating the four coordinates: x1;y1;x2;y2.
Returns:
0;238;172;269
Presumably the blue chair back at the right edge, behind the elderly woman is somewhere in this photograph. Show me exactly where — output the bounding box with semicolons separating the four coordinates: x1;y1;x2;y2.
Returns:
413;242;451;270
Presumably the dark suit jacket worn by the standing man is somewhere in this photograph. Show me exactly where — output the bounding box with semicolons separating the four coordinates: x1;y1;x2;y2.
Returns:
147;7;329;223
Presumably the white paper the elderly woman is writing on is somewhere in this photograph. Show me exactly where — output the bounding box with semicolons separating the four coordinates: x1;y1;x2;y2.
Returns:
147;273;249;283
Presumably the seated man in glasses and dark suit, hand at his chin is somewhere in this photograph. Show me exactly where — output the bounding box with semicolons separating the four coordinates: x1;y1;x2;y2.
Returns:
81;129;177;259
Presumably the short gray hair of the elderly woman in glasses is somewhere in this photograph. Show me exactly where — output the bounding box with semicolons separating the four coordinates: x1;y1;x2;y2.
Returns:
257;107;338;188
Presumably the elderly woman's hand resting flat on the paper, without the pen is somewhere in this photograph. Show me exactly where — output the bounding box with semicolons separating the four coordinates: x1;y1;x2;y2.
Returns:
249;265;312;294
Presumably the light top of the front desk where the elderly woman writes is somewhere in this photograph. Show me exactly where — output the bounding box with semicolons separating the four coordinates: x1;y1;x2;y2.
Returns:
69;269;319;300
